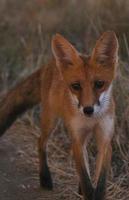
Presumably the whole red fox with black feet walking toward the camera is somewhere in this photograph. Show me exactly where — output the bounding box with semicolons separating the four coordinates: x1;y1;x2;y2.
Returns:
0;31;118;200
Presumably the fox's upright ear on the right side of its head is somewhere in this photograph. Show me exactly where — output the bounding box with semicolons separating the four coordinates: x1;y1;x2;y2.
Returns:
91;31;119;66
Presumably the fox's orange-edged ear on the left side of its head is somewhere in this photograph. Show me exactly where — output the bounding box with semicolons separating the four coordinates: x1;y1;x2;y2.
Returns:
52;34;79;65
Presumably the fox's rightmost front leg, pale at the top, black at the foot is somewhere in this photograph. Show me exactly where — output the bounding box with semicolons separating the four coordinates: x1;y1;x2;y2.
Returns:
95;116;114;200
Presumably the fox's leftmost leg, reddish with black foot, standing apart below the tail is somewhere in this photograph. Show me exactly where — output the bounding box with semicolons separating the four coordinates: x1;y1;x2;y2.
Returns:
38;109;55;190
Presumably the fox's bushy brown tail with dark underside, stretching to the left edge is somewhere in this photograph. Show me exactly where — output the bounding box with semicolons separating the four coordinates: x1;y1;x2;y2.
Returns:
0;69;42;136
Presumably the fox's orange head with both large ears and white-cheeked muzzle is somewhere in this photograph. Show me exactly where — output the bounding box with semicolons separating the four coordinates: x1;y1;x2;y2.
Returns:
52;31;118;117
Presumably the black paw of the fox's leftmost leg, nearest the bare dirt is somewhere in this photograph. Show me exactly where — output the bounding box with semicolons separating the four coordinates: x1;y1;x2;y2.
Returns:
40;167;53;190
